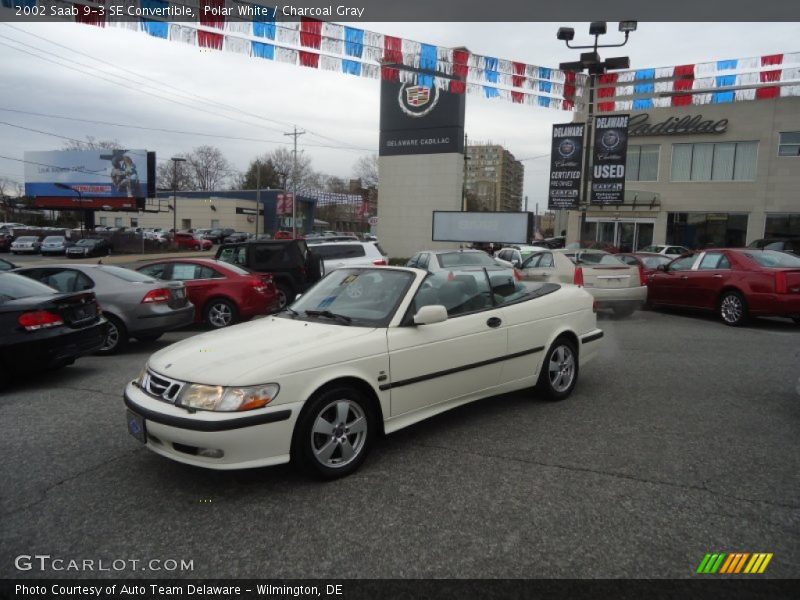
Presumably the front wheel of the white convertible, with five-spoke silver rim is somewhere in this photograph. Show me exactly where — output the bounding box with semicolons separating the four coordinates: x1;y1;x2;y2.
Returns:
292;386;376;479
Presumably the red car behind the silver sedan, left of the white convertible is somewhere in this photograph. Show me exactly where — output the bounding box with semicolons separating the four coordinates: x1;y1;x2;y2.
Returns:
136;258;280;329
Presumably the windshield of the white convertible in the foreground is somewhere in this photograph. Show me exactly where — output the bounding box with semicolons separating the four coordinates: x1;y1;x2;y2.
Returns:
291;267;414;327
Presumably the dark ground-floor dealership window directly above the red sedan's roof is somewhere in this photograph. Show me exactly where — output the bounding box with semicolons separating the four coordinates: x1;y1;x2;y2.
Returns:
667;213;747;249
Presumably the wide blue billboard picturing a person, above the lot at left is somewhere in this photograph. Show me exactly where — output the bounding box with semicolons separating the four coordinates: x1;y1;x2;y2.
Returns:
24;149;150;198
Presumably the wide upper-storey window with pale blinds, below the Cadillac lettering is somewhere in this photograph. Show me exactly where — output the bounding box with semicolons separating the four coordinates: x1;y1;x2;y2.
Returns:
670;142;758;181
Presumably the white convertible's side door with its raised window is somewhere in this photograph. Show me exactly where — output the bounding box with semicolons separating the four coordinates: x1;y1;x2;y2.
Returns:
387;269;508;417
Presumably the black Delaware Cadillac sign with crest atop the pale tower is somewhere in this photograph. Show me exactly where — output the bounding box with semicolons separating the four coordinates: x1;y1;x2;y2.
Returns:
379;80;466;156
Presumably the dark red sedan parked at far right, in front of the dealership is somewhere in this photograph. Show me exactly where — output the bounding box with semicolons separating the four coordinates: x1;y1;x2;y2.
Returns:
648;248;800;326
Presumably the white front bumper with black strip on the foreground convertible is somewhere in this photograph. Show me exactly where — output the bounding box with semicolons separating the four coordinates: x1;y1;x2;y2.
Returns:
124;381;303;470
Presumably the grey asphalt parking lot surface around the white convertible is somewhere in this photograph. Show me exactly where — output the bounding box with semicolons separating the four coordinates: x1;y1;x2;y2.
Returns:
0;312;800;578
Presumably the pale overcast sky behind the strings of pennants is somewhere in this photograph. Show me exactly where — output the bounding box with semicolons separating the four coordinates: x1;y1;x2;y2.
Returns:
0;23;800;210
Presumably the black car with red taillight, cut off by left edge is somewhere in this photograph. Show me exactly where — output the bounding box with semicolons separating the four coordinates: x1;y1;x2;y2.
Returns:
0;272;106;387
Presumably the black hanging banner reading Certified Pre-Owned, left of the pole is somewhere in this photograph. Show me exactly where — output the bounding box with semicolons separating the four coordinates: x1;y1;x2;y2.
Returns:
547;123;585;210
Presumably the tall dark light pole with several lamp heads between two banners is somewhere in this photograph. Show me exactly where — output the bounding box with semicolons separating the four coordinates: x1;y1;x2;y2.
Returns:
556;21;638;244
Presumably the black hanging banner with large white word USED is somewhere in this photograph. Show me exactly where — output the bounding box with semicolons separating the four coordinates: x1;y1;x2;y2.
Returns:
590;115;630;204
